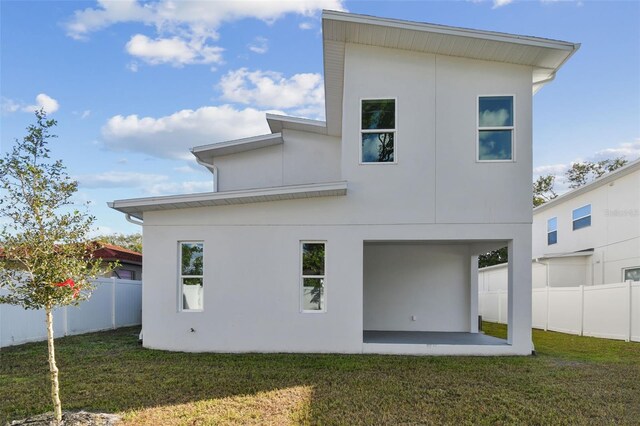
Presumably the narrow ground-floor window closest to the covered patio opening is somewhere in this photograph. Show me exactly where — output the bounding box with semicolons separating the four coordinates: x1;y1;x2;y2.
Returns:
300;241;327;312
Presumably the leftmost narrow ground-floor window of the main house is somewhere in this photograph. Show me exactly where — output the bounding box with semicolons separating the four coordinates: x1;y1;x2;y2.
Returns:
180;242;204;311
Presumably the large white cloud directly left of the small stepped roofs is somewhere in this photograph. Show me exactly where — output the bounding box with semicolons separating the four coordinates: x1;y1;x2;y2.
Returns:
102;105;269;159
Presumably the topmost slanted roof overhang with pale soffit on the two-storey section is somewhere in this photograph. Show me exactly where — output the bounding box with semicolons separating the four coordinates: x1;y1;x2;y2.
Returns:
322;10;580;135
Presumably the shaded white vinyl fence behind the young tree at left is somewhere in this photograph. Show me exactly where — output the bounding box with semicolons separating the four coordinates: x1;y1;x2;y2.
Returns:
0;278;142;348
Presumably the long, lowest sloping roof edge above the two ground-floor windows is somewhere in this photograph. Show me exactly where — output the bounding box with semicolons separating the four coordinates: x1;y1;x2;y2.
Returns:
107;181;347;219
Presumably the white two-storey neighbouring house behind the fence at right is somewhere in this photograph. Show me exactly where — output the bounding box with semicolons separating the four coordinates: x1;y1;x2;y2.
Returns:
479;160;640;291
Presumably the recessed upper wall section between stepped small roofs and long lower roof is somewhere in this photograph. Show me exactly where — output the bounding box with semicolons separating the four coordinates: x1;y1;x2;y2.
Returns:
214;130;340;191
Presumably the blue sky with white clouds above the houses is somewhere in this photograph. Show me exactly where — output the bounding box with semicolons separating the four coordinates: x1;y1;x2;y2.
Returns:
0;0;640;234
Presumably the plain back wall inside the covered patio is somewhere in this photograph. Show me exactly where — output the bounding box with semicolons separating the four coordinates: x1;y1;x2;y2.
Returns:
363;244;470;332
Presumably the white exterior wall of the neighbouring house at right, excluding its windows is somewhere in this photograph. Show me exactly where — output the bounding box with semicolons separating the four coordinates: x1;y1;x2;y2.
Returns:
533;171;640;285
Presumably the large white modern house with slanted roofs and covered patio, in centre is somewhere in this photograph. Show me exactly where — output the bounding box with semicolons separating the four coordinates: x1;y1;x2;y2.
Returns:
110;11;579;355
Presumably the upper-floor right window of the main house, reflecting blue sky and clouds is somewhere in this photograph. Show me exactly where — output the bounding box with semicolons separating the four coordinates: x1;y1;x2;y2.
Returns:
478;96;514;161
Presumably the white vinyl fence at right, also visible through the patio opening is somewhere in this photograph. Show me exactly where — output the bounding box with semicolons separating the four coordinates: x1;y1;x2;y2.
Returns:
478;281;640;342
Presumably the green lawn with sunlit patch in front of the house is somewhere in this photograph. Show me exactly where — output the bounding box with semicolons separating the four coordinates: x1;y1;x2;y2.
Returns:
0;323;640;425
